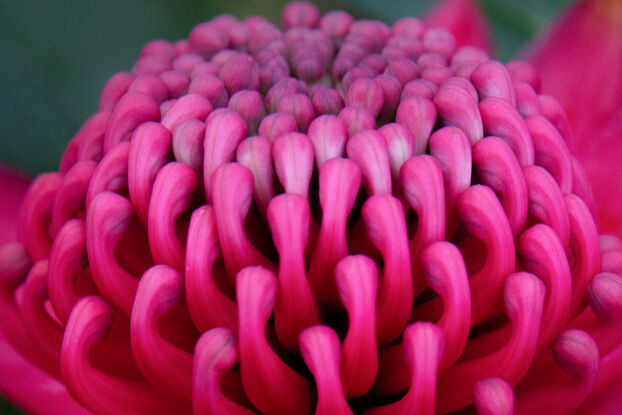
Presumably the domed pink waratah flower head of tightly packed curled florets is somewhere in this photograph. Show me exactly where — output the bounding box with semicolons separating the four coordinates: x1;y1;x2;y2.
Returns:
0;2;622;414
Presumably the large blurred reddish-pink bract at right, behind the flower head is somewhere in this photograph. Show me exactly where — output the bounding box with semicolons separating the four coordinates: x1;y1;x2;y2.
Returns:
527;0;622;242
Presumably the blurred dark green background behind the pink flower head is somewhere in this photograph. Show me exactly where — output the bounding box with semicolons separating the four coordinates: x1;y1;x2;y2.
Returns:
0;0;571;414
